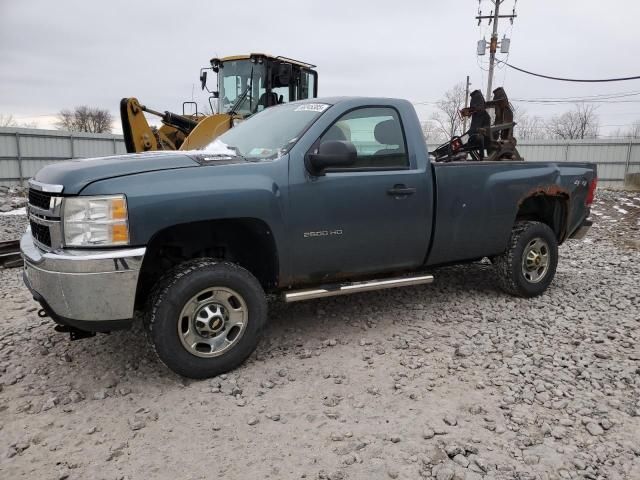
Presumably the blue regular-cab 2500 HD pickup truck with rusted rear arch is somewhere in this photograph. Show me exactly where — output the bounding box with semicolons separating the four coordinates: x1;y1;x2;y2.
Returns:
21;97;596;378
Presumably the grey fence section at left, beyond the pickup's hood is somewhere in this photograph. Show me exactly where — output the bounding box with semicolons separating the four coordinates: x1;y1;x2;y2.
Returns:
0;127;126;185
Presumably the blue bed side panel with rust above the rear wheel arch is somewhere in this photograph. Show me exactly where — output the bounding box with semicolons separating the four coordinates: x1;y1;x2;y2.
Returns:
427;161;596;265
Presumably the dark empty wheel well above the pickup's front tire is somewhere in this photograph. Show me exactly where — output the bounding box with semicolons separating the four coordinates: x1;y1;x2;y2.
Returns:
136;218;279;309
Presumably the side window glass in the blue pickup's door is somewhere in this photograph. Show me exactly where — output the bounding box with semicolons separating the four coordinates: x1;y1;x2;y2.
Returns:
318;107;409;169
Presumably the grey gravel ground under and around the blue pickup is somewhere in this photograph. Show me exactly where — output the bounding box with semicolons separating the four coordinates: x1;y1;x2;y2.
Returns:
0;192;640;480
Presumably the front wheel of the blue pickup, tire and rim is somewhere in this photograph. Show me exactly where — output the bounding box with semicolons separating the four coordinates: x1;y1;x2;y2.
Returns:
146;259;267;378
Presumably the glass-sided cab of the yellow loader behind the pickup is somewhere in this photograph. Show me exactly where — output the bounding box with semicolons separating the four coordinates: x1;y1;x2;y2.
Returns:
208;53;318;118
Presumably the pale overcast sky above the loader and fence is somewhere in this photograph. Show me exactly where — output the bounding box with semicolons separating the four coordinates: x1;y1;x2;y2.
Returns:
0;0;640;134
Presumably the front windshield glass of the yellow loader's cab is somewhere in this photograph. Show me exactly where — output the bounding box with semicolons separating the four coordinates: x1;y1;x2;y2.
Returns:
218;60;265;115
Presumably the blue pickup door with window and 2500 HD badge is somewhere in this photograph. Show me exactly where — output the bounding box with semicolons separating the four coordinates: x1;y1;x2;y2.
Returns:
289;106;432;281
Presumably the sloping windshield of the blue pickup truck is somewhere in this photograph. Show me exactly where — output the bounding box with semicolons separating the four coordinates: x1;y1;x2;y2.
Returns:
202;103;330;160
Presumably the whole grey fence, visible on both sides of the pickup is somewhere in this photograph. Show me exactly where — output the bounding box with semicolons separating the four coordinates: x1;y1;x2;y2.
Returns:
0;128;640;187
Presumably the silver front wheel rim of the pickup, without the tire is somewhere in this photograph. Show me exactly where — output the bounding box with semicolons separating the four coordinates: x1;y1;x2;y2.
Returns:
177;287;248;358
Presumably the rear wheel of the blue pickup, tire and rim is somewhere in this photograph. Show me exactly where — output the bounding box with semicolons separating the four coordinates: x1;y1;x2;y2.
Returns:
495;221;558;297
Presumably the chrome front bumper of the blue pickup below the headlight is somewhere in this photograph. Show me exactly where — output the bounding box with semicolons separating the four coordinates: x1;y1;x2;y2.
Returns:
20;231;146;331
